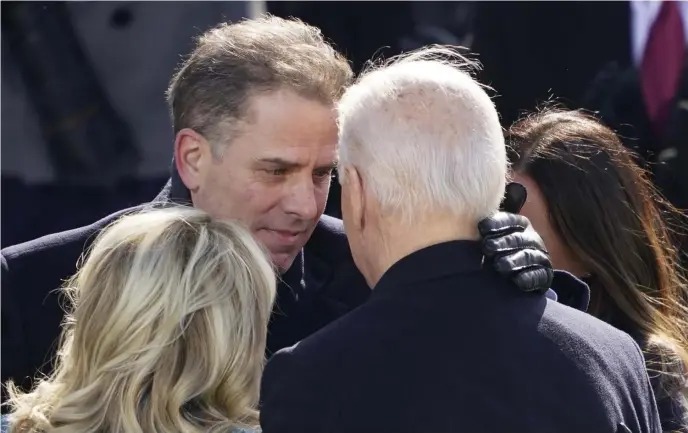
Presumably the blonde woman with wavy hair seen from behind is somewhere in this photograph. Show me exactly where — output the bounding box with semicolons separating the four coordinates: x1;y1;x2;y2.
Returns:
6;207;276;433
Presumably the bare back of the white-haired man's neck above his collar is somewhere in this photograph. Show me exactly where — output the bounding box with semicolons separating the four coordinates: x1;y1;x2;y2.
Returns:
367;218;480;287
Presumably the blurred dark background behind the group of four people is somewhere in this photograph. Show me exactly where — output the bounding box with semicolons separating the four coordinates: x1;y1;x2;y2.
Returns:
0;1;688;246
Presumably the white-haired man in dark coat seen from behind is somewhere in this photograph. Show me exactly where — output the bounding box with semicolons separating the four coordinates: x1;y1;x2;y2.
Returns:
261;47;659;433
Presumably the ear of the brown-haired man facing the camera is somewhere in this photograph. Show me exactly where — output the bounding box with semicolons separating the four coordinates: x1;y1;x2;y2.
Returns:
174;128;210;191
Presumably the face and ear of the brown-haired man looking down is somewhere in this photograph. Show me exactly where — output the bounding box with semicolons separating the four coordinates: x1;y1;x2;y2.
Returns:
175;90;338;272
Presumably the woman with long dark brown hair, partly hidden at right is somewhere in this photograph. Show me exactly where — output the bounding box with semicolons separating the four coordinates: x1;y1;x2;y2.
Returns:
507;111;688;432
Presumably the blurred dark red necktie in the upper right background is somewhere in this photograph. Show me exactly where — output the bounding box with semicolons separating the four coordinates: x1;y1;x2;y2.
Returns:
640;0;686;134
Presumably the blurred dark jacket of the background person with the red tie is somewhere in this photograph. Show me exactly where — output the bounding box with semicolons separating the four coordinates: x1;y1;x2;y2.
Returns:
471;1;688;208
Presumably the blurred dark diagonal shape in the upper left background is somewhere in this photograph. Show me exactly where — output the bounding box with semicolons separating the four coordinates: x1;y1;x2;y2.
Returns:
2;2;138;185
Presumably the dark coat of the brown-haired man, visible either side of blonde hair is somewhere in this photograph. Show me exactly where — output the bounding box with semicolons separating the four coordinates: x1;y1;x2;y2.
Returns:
1;175;370;398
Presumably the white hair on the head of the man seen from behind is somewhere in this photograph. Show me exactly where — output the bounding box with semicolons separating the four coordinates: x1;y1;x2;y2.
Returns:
338;46;508;222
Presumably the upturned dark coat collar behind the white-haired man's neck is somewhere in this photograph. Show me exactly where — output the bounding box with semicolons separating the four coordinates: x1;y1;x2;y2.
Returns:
371;241;483;297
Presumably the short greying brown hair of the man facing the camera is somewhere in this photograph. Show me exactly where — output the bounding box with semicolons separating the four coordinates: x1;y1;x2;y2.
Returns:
167;15;353;148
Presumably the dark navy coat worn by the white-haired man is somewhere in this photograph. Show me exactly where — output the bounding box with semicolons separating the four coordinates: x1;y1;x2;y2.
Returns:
261;241;660;433
